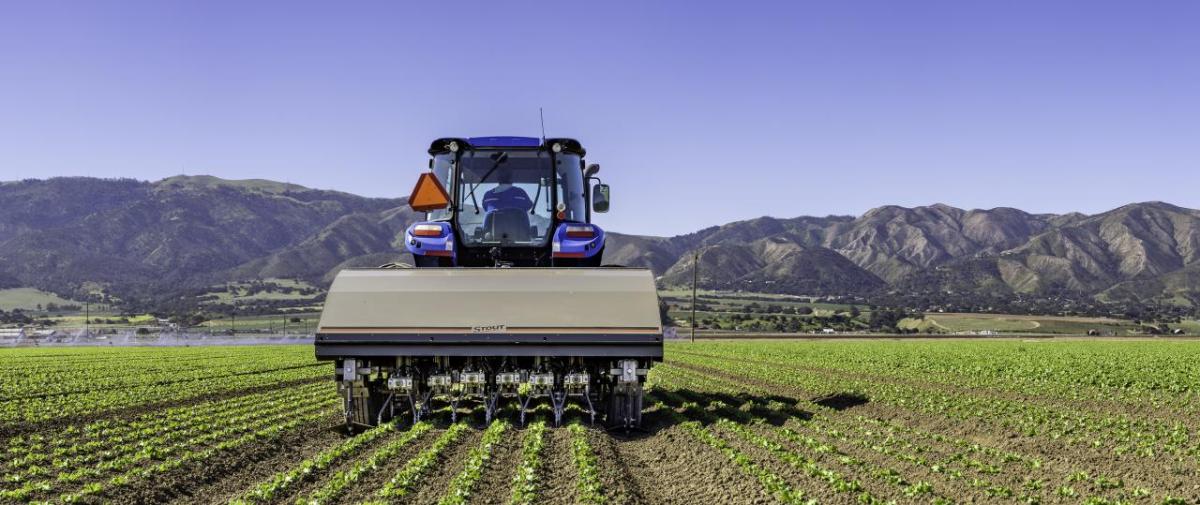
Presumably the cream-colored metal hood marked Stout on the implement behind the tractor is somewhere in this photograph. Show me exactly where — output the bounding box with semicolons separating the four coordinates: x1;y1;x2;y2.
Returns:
317;267;662;355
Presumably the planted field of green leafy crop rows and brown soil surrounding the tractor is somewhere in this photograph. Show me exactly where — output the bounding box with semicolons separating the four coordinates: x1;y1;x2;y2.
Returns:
0;339;1200;504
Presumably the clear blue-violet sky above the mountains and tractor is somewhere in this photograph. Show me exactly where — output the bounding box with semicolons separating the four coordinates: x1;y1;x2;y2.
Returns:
0;0;1200;234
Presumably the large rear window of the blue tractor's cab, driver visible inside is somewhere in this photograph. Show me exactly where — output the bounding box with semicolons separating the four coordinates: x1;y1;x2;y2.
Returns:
456;150;553;246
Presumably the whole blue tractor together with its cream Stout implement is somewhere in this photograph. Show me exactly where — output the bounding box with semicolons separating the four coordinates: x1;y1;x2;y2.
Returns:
314;137;662;429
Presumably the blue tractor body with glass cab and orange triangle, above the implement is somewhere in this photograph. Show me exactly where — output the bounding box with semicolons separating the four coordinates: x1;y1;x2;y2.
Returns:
404;137;608;266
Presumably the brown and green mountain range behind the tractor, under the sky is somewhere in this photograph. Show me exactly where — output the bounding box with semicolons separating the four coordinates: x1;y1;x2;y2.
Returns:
0;176;1200;307
